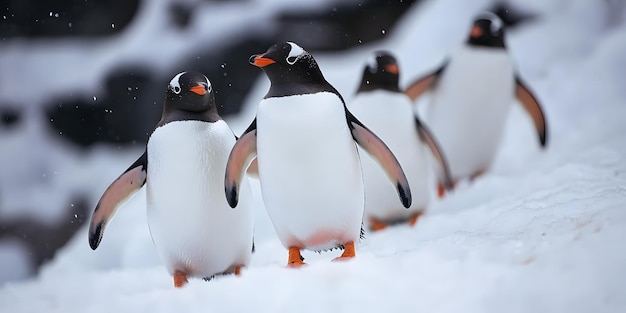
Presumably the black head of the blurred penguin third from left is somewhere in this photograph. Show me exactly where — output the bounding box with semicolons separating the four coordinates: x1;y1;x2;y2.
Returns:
357;51;400;92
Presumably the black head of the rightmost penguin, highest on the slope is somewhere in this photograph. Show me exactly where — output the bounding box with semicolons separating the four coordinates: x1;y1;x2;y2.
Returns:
467;12;504;48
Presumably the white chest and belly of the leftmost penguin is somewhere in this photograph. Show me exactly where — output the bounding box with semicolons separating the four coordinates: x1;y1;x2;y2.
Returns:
146;121;253;277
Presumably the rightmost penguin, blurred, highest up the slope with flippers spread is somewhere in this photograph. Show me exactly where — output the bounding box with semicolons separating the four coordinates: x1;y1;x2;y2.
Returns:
405;12;547;195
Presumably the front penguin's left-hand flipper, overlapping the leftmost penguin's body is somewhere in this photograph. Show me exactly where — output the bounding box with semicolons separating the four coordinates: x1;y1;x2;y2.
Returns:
224;119;256;208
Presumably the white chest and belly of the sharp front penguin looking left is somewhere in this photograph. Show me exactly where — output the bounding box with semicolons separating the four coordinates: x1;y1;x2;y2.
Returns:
257;92;364;250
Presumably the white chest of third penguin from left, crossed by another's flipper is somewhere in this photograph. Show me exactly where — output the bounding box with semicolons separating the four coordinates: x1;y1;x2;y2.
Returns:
350;90;430;220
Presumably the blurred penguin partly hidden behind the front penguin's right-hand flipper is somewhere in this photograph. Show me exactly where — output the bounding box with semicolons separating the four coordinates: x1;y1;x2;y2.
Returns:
348;51;452;231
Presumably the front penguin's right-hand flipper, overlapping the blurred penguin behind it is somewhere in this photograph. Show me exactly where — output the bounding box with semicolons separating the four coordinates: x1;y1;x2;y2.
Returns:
346;110;412;208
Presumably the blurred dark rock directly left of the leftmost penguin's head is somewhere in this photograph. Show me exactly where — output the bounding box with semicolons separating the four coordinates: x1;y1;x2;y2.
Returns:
47;67;165;147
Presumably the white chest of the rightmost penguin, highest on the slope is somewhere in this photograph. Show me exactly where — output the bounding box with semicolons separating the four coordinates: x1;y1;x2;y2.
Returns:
426;46;514;179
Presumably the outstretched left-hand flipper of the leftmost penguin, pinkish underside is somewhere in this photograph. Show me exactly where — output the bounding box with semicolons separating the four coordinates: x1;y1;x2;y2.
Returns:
89;150;148;250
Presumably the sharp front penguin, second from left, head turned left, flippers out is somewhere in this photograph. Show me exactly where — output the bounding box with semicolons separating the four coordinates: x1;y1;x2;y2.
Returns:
225;42;411;267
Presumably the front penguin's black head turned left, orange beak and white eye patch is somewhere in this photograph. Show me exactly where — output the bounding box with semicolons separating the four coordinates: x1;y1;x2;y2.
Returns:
249;41;327;93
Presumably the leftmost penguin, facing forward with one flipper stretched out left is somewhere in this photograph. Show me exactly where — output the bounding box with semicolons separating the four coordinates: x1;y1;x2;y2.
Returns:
89;72;254;287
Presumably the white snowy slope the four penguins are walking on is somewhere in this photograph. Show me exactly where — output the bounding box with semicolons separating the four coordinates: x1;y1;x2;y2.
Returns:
0;0;626;313
